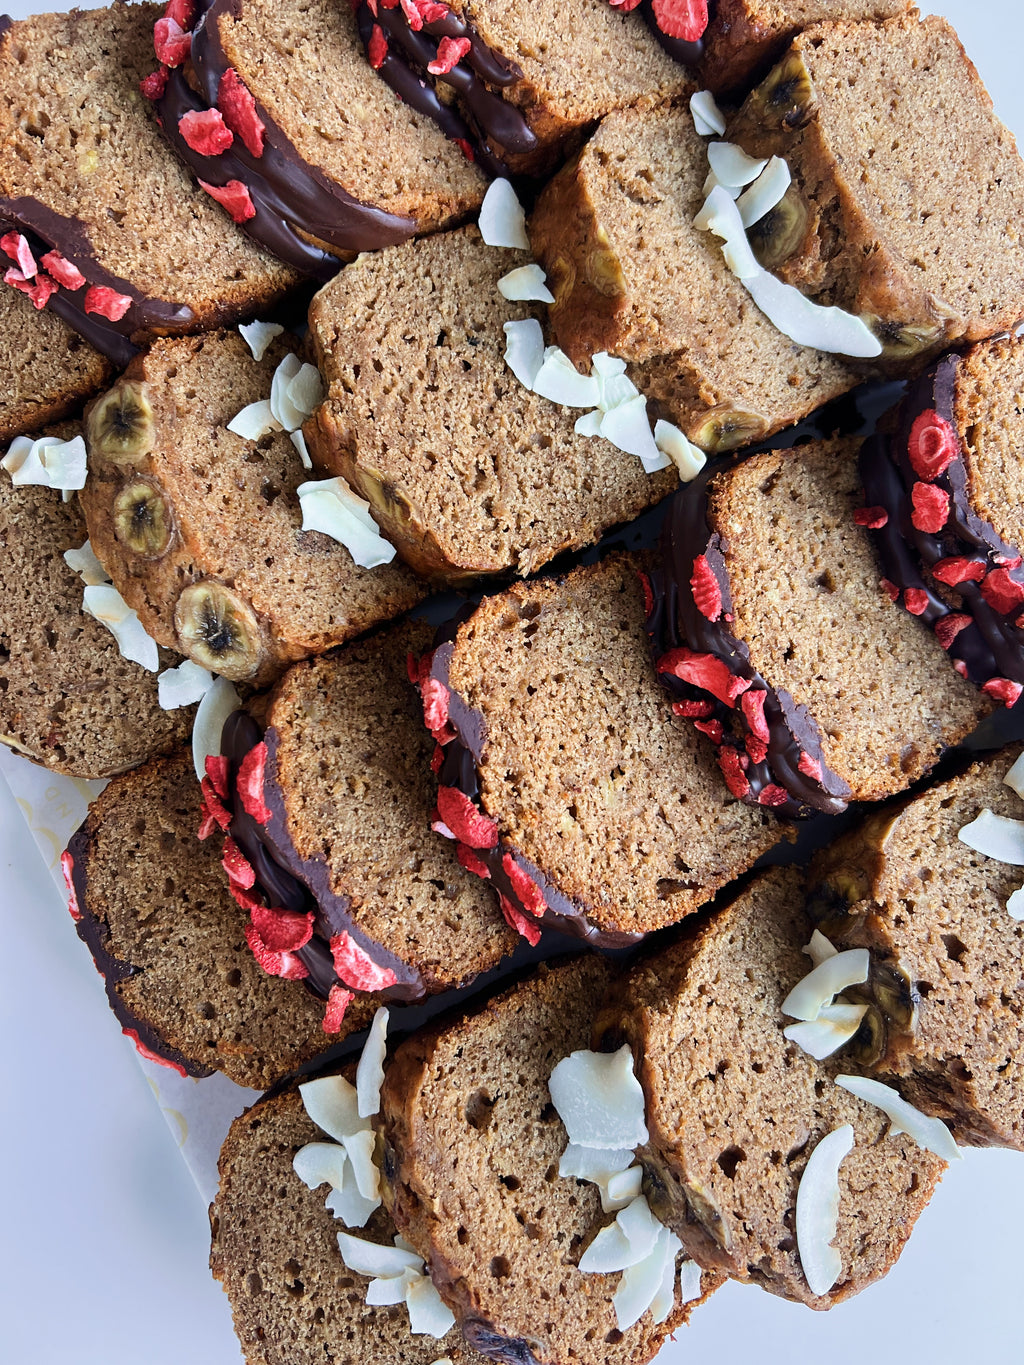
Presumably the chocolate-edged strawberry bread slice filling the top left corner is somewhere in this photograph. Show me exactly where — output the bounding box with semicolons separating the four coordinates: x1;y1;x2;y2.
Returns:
0;0;299;367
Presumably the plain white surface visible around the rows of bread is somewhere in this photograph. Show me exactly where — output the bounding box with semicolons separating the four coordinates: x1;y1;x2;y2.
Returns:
0;0;1024;1365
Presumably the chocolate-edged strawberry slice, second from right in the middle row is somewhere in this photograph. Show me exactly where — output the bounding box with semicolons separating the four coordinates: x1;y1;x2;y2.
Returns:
651;438;990;814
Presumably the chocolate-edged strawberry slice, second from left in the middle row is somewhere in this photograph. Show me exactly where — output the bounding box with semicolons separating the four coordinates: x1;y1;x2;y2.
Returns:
224;621;515;1017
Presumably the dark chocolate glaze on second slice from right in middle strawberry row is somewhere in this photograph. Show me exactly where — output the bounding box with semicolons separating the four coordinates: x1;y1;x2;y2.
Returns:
647;470;851;818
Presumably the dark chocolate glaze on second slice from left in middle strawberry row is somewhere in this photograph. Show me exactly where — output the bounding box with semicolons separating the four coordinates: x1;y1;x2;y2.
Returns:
221;711;426;1002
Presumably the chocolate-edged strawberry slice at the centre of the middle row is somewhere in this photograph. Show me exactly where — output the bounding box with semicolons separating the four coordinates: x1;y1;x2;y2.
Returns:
422;556;782;946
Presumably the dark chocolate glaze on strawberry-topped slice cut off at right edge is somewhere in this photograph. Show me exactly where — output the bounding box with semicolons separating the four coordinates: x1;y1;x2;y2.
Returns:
860;354;1024;687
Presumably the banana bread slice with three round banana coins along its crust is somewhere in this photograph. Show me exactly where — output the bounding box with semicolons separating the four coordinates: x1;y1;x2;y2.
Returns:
82;332;426;685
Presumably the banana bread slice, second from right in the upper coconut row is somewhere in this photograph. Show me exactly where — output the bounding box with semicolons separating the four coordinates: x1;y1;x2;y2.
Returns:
528;106;860;452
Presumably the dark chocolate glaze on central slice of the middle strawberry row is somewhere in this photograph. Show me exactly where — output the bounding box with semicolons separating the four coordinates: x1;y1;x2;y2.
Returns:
430;633;643;949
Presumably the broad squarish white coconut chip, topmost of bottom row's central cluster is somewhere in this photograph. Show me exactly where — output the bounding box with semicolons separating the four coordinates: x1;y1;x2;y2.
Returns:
547;1043;647;1149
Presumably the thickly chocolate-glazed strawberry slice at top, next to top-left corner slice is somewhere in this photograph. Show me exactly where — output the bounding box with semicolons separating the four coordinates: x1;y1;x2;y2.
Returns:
156;0;486;280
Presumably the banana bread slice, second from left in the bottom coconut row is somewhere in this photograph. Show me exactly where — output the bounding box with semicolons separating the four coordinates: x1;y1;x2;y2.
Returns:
381;957;717;1365
